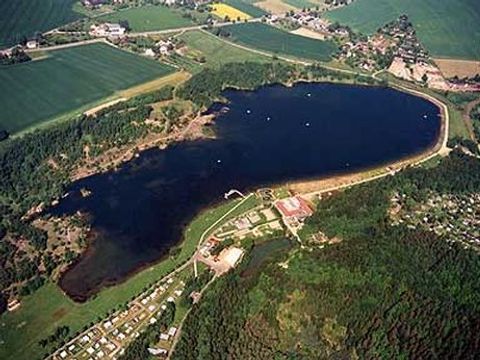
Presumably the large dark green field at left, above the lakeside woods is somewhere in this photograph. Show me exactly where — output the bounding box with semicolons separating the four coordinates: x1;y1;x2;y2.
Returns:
0;44;173;133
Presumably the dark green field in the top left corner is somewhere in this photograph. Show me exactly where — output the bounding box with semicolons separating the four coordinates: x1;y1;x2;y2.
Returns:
0;0;81;48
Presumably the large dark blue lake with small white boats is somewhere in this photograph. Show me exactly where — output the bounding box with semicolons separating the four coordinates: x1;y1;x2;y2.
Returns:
51;84;440;301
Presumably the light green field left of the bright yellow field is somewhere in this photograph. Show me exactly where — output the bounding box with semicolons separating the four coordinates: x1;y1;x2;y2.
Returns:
95;5;194;32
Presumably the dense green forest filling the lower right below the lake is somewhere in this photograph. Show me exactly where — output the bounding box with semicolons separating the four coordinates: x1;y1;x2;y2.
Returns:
173;151;480;359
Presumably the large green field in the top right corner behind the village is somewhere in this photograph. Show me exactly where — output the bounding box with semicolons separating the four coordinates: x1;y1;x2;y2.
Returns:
327;0;480;60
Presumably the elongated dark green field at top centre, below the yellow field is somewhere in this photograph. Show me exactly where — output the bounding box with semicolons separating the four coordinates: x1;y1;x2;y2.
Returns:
224;23;336;61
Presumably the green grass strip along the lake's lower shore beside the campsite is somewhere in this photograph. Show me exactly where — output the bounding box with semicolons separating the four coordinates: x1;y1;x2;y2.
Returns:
0;196;258;360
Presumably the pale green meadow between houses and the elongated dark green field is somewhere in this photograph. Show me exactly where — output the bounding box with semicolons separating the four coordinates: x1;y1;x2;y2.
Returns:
179;30;271;71
